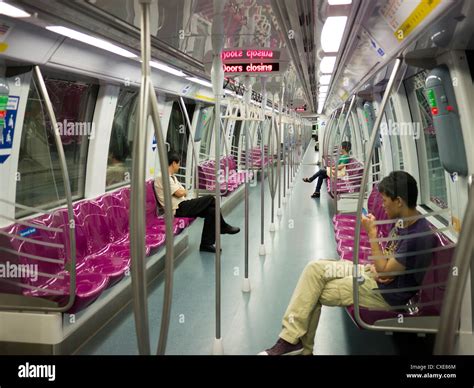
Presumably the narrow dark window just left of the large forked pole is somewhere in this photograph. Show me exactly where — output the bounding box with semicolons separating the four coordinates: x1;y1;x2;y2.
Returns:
106;89;138;188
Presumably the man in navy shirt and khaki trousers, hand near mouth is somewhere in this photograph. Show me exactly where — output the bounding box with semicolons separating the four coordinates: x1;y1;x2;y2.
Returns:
260;171;435;355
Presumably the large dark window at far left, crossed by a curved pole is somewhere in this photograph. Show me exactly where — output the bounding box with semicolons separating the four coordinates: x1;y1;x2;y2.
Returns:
16;78;98;217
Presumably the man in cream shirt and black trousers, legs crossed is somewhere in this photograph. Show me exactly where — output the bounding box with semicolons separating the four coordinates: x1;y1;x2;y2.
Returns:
155;152;240;252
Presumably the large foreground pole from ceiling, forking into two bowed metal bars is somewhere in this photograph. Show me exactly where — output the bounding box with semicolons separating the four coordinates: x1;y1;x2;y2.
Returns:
130;0;174;354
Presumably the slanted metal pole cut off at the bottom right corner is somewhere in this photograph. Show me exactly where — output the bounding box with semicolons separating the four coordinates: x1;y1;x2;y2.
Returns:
433;183;474;355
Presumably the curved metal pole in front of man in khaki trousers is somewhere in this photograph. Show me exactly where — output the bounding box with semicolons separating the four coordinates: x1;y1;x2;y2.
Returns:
352;58;422;332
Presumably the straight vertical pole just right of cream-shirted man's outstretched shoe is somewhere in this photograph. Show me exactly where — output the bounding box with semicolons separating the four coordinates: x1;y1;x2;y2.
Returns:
244;76;252;292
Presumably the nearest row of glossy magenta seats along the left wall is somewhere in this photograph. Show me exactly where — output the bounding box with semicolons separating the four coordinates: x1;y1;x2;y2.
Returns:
0;181;193;312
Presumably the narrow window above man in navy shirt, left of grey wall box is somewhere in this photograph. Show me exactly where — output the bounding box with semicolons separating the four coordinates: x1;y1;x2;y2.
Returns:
405;71;448;209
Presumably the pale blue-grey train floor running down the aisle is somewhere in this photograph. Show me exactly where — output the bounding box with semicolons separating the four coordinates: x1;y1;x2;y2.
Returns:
78;145;433;355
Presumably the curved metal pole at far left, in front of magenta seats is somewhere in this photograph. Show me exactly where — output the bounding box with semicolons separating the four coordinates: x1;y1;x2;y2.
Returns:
32;66;76;311
